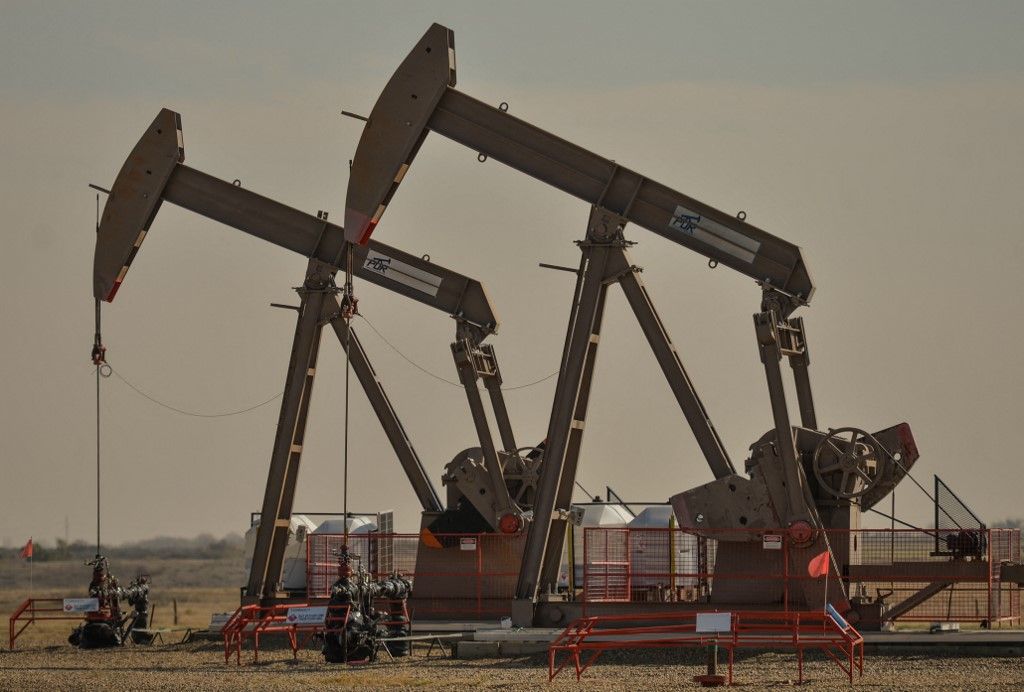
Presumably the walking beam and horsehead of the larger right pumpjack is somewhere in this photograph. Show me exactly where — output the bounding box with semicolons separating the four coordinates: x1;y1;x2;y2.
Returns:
345;24;814;304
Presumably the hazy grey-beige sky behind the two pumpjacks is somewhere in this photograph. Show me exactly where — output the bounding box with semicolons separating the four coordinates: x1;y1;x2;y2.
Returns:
0;0;1024;545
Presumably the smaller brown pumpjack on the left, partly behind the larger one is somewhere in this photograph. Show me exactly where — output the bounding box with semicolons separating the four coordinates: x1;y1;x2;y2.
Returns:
93;109;543;603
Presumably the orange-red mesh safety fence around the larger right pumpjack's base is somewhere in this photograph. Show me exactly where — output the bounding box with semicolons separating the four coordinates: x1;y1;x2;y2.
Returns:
574;527;1021;625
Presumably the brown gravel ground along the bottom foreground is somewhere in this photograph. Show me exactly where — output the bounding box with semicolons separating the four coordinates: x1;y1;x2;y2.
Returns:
0;644;1024;692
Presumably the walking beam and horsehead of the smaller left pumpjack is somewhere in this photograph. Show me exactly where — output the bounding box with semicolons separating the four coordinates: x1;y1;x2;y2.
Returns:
93;109;498;339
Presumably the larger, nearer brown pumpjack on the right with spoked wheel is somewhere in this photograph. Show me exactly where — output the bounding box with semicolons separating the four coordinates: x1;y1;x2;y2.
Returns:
345;24;919;624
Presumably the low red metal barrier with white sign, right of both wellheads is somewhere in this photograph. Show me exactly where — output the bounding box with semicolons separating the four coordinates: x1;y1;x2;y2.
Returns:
548;611;864;685
